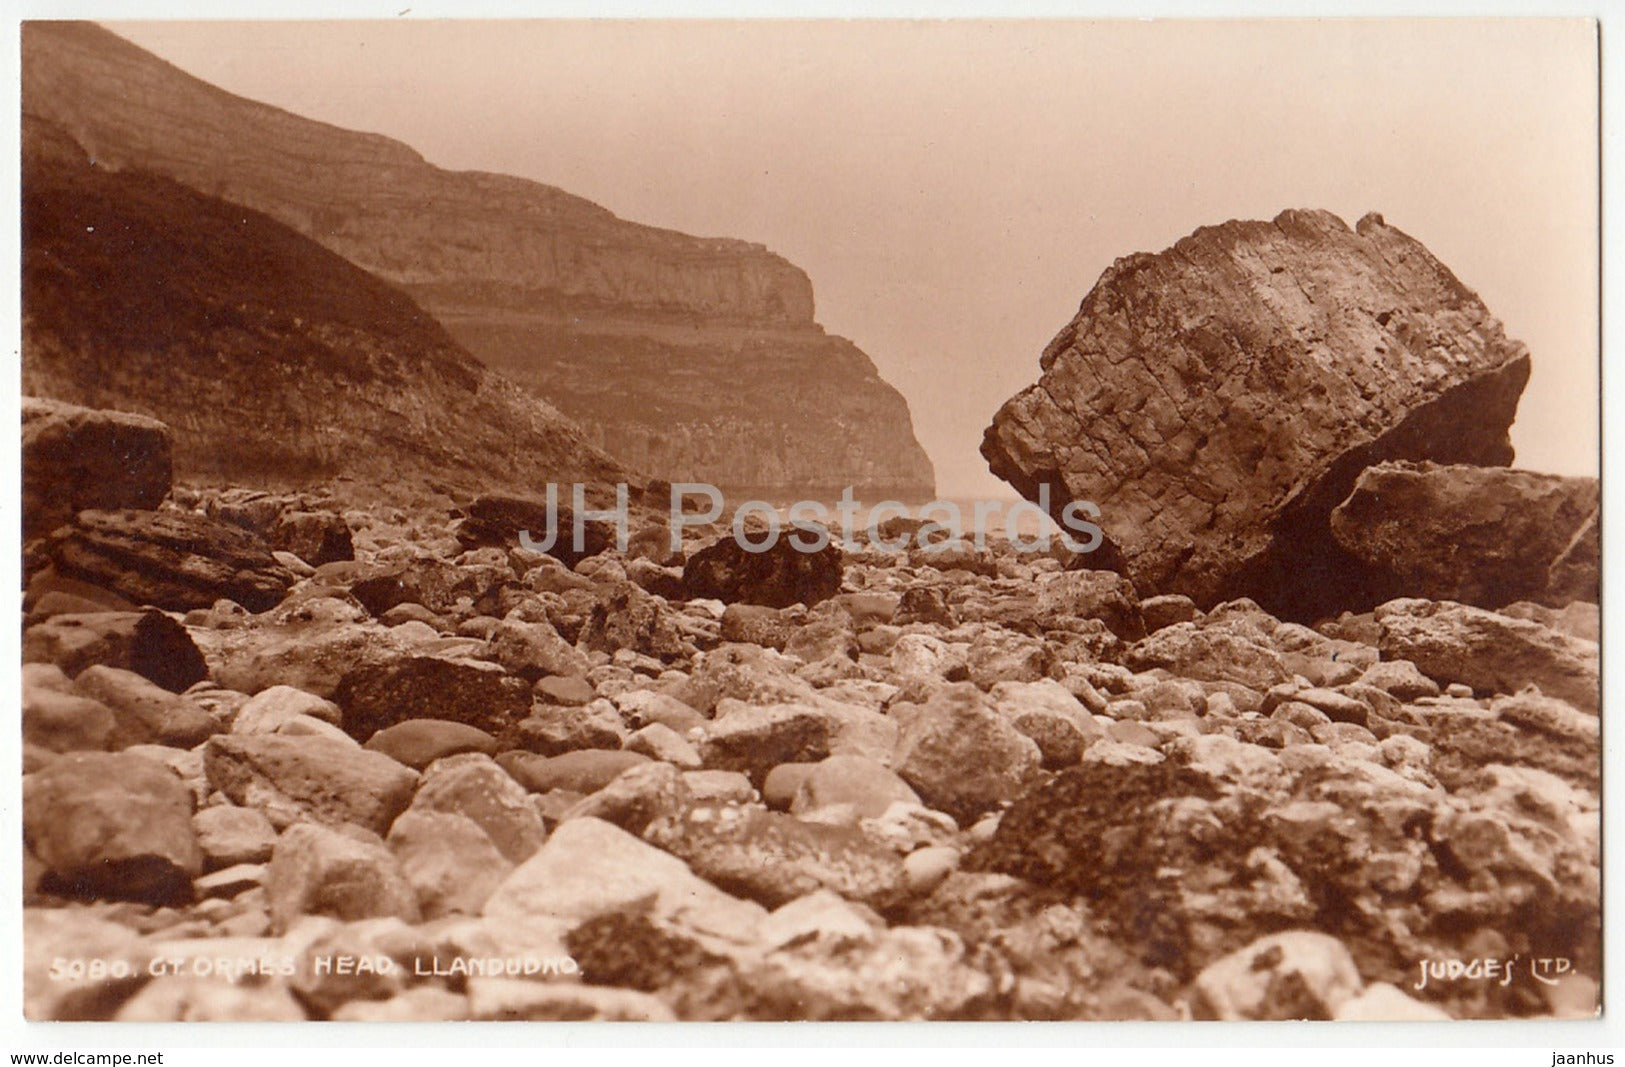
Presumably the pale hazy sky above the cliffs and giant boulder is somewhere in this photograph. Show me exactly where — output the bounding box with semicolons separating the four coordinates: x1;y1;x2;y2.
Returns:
109;19;1597;495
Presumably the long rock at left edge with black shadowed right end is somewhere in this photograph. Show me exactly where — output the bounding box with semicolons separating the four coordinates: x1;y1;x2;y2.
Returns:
23;611;208;692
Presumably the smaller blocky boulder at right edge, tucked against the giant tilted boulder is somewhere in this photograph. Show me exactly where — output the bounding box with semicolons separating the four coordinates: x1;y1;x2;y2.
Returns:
1331;463;1602;607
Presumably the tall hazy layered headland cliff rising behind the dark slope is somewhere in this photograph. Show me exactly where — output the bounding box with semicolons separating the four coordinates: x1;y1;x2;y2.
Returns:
23;23;933;494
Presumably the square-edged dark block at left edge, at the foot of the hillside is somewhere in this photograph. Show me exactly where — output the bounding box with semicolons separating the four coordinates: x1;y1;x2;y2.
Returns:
23;396;174;541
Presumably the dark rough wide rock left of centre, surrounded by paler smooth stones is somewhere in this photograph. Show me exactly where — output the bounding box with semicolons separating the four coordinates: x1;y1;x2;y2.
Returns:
333;654;530;741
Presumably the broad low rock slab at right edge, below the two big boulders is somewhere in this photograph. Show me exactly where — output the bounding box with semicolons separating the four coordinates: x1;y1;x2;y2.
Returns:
1376;599;1602;715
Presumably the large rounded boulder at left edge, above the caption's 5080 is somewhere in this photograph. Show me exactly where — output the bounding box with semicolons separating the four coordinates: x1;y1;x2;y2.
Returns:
23;752;203;905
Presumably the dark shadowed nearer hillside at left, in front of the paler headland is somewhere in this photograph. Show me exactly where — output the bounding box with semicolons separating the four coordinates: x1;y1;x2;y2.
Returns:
23;114;640;494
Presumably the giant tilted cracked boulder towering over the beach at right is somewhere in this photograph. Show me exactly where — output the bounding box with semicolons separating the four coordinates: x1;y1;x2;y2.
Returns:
982;211;1529;619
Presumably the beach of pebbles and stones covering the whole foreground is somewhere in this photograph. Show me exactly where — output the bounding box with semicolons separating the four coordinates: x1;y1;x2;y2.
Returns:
23;490;1601;1020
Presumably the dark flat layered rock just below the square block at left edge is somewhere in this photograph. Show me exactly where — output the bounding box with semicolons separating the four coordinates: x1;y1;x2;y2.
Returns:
44;510;294;611
